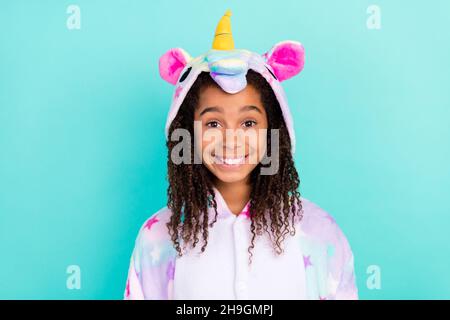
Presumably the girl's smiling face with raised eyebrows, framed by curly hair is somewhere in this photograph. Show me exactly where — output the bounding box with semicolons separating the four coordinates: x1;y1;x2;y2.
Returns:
194;85;268;183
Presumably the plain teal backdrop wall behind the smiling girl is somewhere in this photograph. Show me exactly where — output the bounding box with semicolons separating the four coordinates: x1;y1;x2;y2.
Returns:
0;0;450;299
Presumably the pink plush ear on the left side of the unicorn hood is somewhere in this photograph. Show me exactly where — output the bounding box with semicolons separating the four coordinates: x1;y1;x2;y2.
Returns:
159;48;192;85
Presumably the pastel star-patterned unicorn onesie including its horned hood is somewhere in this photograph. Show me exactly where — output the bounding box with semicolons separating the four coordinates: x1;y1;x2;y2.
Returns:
124;11;358;300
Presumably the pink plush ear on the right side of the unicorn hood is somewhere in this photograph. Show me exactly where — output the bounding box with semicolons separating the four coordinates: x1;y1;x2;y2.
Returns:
263;41;305;82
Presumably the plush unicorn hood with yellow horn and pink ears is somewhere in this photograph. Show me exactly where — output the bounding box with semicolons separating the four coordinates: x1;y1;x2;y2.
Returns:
159;10;305;154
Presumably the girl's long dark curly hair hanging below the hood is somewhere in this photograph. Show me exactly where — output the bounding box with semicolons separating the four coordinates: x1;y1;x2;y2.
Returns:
167;70;303;264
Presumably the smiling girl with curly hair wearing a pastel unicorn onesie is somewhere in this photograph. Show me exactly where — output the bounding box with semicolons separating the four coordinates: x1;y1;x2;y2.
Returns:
124;11;358;299
